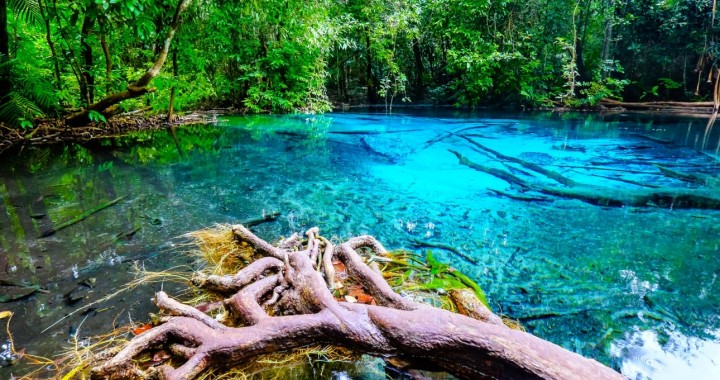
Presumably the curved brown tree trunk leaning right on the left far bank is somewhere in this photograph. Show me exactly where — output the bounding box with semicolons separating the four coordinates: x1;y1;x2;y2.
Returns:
65;0;192;125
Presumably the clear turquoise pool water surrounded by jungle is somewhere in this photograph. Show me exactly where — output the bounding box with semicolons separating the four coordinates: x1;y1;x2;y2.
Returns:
0;111;720;379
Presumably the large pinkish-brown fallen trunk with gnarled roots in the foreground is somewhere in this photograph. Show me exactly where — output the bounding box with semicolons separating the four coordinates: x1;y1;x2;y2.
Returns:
92;225;623;379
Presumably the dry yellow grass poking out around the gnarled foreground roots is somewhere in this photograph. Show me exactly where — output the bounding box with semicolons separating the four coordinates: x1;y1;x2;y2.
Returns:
31;224;522;380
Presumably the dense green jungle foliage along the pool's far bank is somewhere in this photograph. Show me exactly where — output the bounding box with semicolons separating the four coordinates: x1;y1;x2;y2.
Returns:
0;0;718;127
